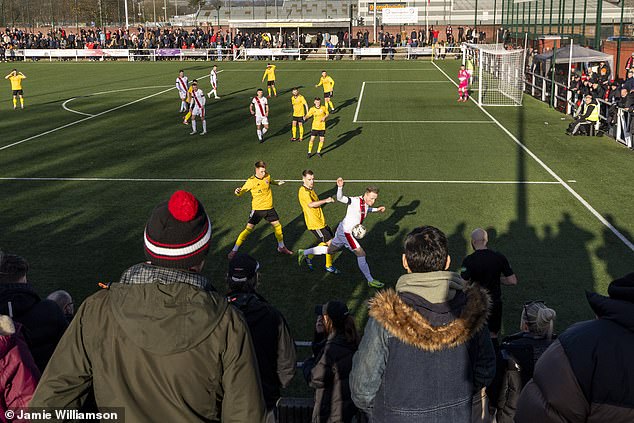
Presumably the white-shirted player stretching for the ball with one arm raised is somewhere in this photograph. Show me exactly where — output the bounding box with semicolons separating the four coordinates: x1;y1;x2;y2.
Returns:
297;178;385;288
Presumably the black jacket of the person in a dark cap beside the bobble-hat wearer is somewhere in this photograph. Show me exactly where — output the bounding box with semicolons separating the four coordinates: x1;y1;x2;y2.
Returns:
227;292;296;409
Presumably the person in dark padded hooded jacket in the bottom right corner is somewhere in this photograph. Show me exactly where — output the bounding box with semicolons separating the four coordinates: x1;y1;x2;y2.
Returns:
515;273;634;423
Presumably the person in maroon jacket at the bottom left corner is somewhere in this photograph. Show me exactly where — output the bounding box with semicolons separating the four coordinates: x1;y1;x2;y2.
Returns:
0;315;40;423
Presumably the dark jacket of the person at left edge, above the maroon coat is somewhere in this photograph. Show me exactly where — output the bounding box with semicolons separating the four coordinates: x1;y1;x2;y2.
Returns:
0;283;68;372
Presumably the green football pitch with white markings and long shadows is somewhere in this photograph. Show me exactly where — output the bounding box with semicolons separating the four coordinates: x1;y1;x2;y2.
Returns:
0;60;634;366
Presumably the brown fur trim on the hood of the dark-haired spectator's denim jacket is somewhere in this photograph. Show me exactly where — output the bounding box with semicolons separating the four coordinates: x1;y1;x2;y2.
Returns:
369;274;491;351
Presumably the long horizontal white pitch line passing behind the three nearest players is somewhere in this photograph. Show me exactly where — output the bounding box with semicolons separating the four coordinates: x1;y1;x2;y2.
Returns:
0;177;559;185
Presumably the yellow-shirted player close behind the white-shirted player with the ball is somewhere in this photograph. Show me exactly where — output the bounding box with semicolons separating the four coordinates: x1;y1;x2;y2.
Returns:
297;169;341;274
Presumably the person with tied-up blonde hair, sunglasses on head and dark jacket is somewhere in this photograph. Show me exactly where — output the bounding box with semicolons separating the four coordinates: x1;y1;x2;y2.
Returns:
492;301;557;423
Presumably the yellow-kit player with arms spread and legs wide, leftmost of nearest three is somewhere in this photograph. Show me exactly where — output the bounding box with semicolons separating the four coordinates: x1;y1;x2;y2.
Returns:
228;161;293;260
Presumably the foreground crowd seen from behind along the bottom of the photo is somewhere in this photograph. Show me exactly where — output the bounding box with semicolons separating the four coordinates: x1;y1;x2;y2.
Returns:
0;191;634;423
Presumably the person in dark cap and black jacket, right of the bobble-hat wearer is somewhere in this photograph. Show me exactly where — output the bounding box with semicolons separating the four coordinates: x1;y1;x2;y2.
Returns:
227;253;297;423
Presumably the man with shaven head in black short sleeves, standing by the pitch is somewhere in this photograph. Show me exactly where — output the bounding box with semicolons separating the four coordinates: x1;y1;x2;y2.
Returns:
460;228;517;347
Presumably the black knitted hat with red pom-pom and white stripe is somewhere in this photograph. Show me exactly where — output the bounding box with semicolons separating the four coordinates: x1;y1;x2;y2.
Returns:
144;191;211;269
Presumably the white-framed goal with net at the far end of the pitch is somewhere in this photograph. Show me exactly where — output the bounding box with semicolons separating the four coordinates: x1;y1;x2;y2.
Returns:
463;44;525;106
